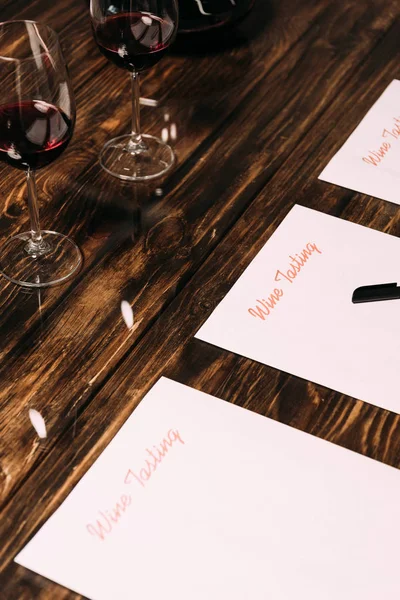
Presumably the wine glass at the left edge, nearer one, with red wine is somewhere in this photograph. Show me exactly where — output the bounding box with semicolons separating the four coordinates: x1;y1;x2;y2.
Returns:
0;21;82;287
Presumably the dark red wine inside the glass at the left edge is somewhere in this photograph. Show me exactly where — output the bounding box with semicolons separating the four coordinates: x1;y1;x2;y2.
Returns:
0;100;73;170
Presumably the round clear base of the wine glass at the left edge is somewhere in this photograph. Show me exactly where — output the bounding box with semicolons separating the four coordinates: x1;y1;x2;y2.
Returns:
0;231;82;288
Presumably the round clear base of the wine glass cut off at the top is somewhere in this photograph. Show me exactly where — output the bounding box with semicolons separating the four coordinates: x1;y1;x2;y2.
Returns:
100;134;175;181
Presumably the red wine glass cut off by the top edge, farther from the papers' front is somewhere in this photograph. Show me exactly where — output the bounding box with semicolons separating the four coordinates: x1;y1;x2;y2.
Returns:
90;0;178;181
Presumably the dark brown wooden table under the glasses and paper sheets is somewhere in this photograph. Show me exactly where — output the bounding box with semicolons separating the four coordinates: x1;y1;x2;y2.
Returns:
0;0;400;600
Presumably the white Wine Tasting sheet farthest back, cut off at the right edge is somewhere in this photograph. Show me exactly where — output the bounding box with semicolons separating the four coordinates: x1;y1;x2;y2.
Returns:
319;79;400;204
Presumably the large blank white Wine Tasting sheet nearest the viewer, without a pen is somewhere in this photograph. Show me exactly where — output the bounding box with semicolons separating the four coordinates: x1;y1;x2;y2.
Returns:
16;378;400;600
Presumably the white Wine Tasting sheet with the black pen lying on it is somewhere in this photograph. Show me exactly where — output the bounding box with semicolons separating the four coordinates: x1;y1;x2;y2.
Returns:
196;205;400;413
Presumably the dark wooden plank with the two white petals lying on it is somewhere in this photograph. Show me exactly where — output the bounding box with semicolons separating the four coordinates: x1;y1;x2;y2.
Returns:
0;0;394;516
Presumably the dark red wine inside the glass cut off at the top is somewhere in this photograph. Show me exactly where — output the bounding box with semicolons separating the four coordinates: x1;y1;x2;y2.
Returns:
94;12;175;71
